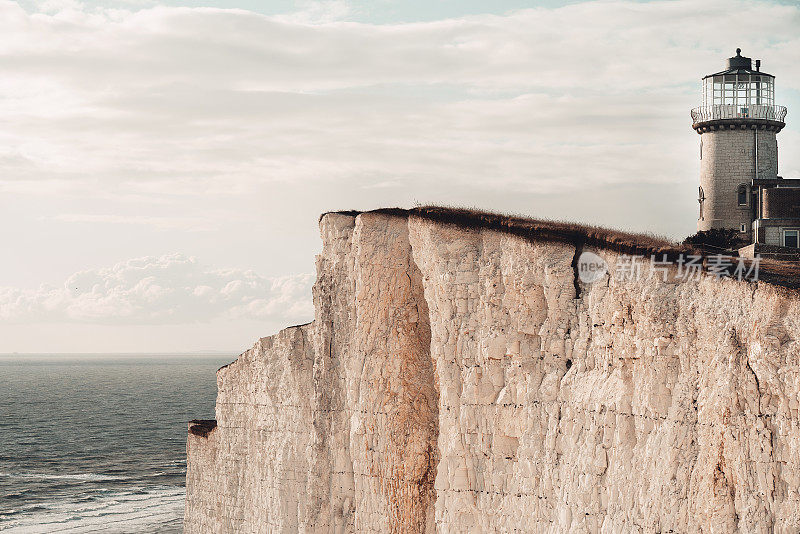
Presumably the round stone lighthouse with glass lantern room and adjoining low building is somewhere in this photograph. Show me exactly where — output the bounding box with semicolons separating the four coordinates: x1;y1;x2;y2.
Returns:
692;49;800;249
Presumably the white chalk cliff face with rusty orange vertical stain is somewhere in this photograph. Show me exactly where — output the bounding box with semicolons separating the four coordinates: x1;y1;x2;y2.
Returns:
185;213;800;533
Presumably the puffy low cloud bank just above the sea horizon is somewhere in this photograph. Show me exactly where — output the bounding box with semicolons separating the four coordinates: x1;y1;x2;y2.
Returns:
0;254;314;324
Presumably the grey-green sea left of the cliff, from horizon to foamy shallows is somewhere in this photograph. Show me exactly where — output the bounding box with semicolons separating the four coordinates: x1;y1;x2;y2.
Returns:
0;354;235;534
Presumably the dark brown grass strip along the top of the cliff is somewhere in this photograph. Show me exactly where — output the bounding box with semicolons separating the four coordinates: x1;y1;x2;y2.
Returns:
320;206;800;289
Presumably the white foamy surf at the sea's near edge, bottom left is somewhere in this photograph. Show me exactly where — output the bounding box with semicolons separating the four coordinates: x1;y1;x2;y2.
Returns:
0;487;185;534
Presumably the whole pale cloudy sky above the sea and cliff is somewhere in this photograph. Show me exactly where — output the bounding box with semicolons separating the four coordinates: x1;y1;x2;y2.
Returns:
0;0;800;353
